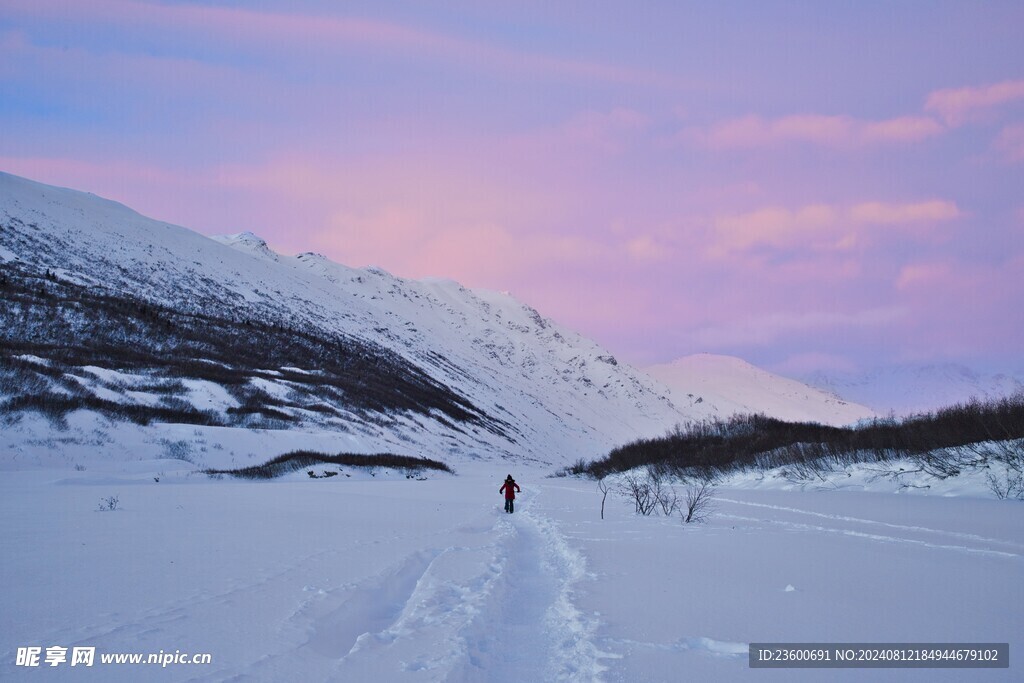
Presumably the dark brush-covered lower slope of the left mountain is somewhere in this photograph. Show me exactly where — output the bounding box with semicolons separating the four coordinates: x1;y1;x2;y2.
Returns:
0;262;487;430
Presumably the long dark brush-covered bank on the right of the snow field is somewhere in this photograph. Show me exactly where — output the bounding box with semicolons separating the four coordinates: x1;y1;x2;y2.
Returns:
570;394;1024;478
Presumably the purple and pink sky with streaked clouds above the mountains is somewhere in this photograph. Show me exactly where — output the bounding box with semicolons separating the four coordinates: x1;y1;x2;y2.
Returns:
0;0;1024;375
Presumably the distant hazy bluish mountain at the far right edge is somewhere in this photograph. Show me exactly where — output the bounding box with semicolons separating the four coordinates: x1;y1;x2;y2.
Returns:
804;364;1024;416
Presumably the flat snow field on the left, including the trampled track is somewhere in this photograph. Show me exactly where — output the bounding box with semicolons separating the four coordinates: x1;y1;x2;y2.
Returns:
0;464;600;681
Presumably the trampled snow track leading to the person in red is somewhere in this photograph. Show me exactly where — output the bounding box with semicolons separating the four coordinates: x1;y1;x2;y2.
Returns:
327;494;603;682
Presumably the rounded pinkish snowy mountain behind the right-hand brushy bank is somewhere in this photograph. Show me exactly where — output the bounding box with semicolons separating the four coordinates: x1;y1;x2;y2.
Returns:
646;353;874;425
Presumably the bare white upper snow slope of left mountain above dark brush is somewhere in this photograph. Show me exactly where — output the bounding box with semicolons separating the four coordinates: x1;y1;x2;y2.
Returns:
0;174;693;463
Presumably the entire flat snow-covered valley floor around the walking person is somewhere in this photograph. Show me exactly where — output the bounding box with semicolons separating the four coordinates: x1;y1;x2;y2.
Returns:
0;460;1024;682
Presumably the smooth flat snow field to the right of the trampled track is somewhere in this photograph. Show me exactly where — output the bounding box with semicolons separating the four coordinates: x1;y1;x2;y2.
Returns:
528;479;1024;681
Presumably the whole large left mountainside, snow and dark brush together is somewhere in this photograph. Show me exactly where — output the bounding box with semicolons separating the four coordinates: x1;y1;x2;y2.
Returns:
0;174;693;466
